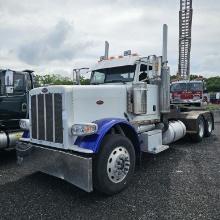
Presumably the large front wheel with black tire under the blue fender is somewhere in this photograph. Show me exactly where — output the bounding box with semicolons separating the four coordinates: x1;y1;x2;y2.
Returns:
93;134;135;195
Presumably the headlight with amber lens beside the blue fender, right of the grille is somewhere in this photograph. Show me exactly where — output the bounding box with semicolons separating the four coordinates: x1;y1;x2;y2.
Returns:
71;123;98;136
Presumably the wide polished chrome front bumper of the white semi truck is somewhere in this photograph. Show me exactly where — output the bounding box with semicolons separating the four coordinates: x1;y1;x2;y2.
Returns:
16;141;93;192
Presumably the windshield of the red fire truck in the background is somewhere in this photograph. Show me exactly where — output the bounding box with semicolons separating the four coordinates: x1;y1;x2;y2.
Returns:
170;82;203;92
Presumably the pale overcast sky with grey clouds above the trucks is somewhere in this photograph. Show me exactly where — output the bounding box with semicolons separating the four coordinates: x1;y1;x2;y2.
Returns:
0;0;220;76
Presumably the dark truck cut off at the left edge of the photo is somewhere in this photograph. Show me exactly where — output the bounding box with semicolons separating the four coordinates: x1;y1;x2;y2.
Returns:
0;70;34;150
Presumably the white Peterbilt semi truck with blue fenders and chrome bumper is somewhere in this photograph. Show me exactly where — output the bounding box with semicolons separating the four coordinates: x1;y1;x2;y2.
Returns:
17;25;214;194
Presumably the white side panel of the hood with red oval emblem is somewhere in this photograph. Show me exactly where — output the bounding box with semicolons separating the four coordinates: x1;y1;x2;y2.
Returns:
73;85;127;123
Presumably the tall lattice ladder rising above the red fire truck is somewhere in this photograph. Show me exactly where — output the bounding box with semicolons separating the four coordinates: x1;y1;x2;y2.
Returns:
178;0;193;80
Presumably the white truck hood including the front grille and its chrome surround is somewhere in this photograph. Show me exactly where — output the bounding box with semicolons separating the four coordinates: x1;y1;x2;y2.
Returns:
29;85;127;149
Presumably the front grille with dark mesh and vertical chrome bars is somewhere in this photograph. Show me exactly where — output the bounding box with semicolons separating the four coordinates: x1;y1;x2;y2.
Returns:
31;93;63;143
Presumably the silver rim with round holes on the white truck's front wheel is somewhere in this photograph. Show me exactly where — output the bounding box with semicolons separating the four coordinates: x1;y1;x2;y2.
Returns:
107;146;130;183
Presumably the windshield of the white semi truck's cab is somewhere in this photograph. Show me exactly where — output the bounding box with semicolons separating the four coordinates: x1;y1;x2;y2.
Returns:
90;65;136;84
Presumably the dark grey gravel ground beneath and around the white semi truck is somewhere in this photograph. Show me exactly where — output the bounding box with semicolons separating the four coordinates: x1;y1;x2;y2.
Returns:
0;123;220;219
